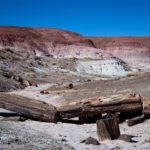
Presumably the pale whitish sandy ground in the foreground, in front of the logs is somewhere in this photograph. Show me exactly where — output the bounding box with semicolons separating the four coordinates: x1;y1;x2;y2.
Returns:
0;109;150;150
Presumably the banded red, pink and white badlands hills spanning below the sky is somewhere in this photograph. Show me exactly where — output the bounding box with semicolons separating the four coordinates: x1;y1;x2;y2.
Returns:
0;26;150;91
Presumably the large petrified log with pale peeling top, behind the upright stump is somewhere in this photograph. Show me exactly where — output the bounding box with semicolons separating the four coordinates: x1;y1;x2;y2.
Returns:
57;94;143;119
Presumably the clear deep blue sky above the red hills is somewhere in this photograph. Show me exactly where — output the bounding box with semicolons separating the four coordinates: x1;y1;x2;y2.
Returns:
0;0;150;36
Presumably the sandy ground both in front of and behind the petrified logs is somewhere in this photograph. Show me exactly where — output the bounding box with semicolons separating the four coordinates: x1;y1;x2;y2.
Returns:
0;74;150;150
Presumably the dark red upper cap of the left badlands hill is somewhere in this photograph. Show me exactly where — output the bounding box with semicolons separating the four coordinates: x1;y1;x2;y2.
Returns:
0;26;94;55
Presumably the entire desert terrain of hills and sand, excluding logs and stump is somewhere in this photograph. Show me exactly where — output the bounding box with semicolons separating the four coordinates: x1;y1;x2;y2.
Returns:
0;27;150;150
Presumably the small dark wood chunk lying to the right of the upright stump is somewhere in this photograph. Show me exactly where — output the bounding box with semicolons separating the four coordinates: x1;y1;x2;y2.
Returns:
127;115;145;126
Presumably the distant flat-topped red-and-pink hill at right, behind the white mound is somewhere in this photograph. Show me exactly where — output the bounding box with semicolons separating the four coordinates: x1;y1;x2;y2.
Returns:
88;36;150;67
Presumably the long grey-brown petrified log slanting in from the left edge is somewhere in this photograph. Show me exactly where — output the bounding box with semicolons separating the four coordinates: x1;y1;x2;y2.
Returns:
0;93;59;122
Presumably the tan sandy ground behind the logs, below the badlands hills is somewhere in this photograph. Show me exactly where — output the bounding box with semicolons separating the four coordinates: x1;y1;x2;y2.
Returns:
11;73;150;107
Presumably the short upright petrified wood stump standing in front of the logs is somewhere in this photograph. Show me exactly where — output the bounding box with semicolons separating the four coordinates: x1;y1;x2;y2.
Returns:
96;117;120;141
